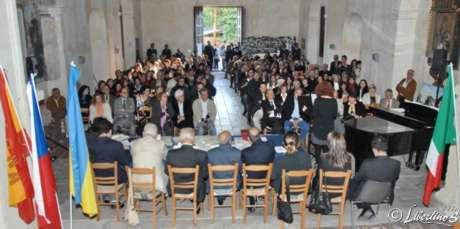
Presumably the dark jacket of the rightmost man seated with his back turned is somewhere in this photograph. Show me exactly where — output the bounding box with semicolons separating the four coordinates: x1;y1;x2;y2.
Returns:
349;156;401;202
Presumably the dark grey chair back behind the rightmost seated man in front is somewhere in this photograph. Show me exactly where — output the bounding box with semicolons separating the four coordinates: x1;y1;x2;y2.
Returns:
357;180;393;204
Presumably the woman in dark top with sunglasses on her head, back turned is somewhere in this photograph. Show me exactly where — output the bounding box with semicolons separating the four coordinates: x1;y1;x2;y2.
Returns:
272;132;312;193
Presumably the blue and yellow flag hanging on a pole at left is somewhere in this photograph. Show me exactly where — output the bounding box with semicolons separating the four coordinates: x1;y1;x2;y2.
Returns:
67;66;98;217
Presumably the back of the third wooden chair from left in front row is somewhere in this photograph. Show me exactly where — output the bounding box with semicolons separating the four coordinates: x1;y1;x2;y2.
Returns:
168;165;200;194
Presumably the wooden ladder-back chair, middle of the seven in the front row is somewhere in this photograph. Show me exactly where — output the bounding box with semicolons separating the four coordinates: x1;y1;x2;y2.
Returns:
208;163;238;223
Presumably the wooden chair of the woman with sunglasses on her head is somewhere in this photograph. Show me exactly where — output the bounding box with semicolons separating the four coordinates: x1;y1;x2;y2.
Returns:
280;169;315;229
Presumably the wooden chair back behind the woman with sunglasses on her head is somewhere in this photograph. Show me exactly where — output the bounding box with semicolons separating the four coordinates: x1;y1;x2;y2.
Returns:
281;169;314;200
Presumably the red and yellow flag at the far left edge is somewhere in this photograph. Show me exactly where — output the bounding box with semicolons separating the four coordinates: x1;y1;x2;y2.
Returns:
0;67;35;224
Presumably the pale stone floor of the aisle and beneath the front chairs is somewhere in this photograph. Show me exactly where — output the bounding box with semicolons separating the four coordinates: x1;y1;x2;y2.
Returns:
53;73;447;229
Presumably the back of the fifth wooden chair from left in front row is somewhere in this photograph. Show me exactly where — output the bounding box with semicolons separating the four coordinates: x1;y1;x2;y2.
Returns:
243;163;272;189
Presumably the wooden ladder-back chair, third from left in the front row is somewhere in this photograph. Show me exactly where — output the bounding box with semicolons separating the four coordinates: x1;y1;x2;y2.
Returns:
168;165;200;225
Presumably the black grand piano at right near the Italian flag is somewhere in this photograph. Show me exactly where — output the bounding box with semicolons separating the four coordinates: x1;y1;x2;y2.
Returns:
344;102;438;169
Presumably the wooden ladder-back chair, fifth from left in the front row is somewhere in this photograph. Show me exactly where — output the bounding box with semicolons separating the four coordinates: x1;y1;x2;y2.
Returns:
241;163;272;223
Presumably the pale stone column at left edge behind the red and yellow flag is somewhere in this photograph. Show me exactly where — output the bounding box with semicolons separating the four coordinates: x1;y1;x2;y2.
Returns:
0;0;37;229
